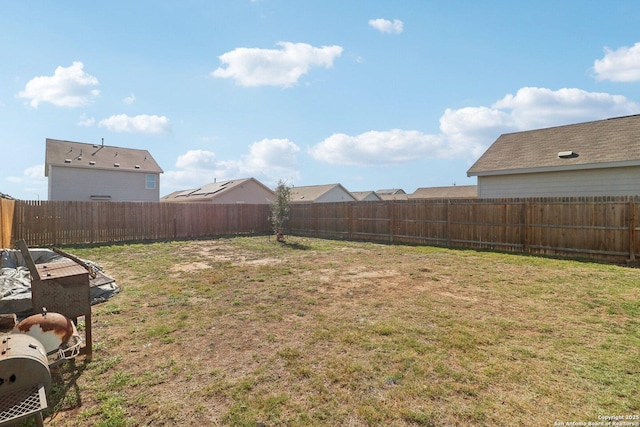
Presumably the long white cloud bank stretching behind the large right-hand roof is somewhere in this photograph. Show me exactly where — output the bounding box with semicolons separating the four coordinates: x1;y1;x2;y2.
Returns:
309;87;640;165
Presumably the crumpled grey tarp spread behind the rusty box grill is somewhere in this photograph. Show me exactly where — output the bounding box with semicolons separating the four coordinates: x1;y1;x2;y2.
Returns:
0;249;120;314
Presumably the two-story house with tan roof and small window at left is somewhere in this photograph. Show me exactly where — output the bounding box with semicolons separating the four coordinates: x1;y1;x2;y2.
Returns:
44;138;163;202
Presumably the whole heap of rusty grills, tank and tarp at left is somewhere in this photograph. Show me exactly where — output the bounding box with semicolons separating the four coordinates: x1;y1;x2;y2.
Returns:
0;247;120;426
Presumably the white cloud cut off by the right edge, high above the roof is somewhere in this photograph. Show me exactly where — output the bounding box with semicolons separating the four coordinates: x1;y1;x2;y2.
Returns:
593;42;640;82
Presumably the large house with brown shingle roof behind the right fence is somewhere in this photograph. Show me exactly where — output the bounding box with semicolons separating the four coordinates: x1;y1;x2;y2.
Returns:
467;115;640;198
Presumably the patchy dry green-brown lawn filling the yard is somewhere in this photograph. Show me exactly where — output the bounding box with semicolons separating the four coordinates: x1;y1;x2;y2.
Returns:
35;237;640;426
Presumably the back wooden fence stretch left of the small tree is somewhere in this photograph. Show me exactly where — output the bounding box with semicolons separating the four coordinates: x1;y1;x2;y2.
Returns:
10;201;270;247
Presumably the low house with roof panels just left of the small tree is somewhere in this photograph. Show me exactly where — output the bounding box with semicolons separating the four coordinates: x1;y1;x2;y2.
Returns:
160;178;275;204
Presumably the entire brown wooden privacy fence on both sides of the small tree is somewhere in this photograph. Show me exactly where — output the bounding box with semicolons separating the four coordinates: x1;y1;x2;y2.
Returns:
5;196;640;262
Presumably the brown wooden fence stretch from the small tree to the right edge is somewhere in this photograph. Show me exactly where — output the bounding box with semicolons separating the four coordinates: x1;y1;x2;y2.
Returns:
288;197;640;262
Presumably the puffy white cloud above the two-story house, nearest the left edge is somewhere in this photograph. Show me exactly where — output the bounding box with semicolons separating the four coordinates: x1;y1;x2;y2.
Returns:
17;61;100;108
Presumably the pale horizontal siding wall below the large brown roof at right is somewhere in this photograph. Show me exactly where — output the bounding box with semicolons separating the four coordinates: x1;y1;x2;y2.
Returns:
478;167;640;198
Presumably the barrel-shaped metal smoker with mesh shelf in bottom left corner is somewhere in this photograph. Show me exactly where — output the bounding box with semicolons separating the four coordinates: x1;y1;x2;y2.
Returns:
0;334;51;426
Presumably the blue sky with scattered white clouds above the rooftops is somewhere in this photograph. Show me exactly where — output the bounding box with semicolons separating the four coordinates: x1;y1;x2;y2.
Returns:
0;0;640;200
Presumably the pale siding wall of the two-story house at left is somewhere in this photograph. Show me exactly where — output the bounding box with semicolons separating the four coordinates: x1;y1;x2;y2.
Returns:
49;166;160;202
